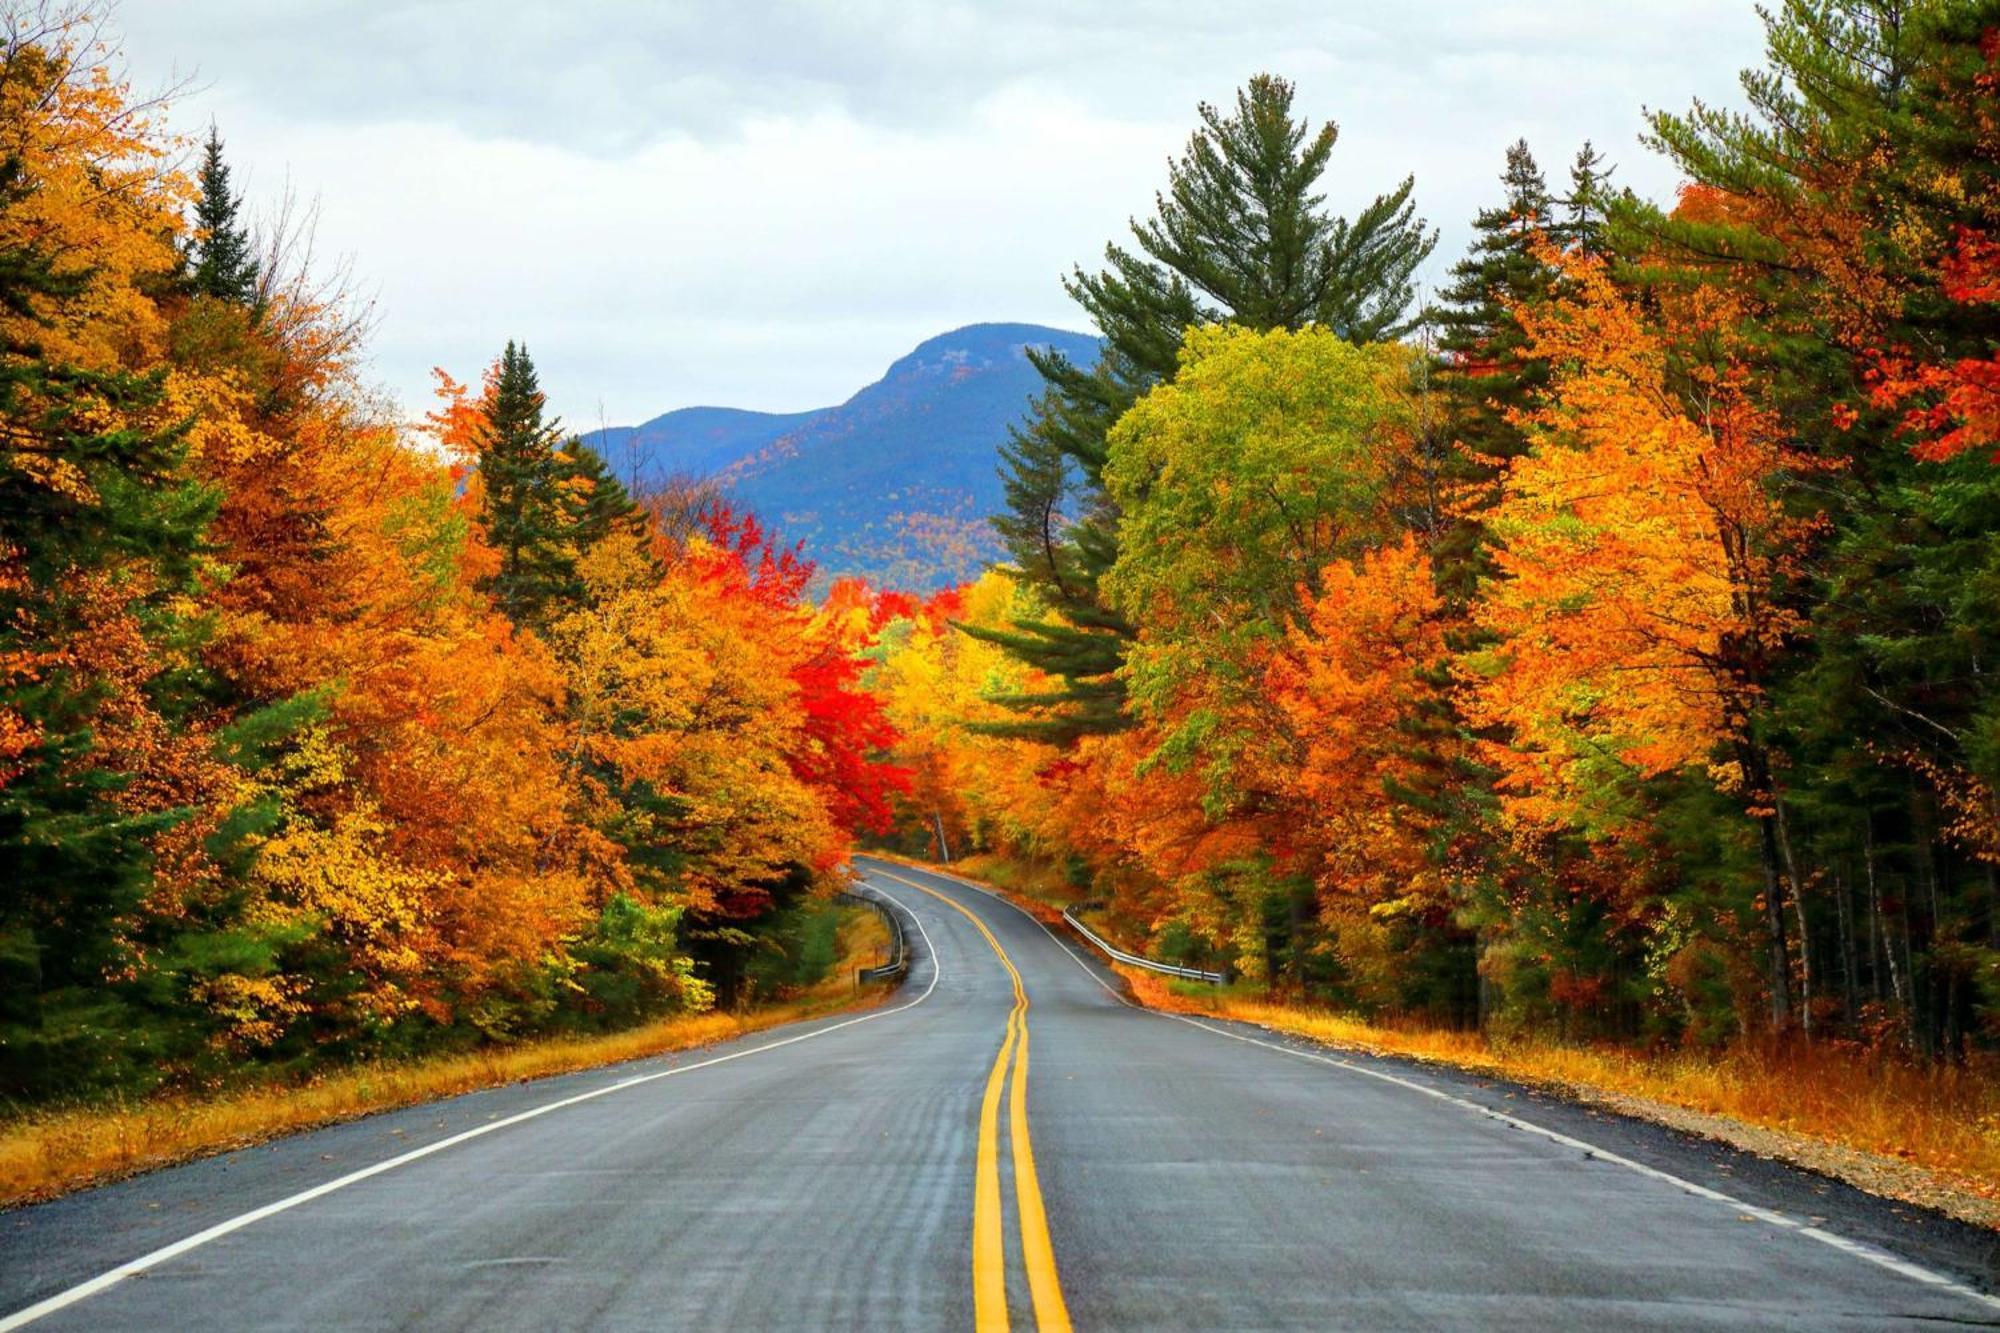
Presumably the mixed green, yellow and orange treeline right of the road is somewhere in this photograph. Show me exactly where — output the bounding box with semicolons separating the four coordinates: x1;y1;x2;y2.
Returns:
880;0;2000;1057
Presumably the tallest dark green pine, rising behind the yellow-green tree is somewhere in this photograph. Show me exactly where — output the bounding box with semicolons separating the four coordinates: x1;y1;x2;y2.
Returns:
966;74;1436;743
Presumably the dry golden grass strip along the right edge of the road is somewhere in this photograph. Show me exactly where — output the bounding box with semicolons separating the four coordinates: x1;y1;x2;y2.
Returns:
1118;969;2000;1225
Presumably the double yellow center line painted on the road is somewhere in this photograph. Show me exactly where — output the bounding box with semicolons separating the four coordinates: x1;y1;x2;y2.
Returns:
870;869;1070;1333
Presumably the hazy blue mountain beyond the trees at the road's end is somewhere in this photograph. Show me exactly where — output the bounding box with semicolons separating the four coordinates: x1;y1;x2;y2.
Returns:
586;324;1098;588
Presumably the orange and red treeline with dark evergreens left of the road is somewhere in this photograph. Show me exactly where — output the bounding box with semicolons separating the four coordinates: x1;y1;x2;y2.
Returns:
0;8;900;1101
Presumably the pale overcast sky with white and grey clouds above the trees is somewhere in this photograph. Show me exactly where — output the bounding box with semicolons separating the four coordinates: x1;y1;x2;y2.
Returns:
116;0;1758;426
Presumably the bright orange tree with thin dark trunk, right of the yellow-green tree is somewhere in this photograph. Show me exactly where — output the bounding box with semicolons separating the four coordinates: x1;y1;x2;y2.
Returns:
1468;258;1808;1027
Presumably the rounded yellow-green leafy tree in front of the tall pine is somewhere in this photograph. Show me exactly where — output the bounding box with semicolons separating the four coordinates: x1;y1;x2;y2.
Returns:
1104;326;1410;780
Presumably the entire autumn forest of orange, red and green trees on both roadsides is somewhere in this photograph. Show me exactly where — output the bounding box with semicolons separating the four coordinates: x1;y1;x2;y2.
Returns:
0;0;2000;1101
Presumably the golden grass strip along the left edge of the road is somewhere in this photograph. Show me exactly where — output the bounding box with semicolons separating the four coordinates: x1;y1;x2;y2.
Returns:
0;911;888;1207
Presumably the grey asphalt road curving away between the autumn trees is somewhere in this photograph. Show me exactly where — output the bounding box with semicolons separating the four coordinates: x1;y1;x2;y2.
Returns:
0;861;2000;1329
